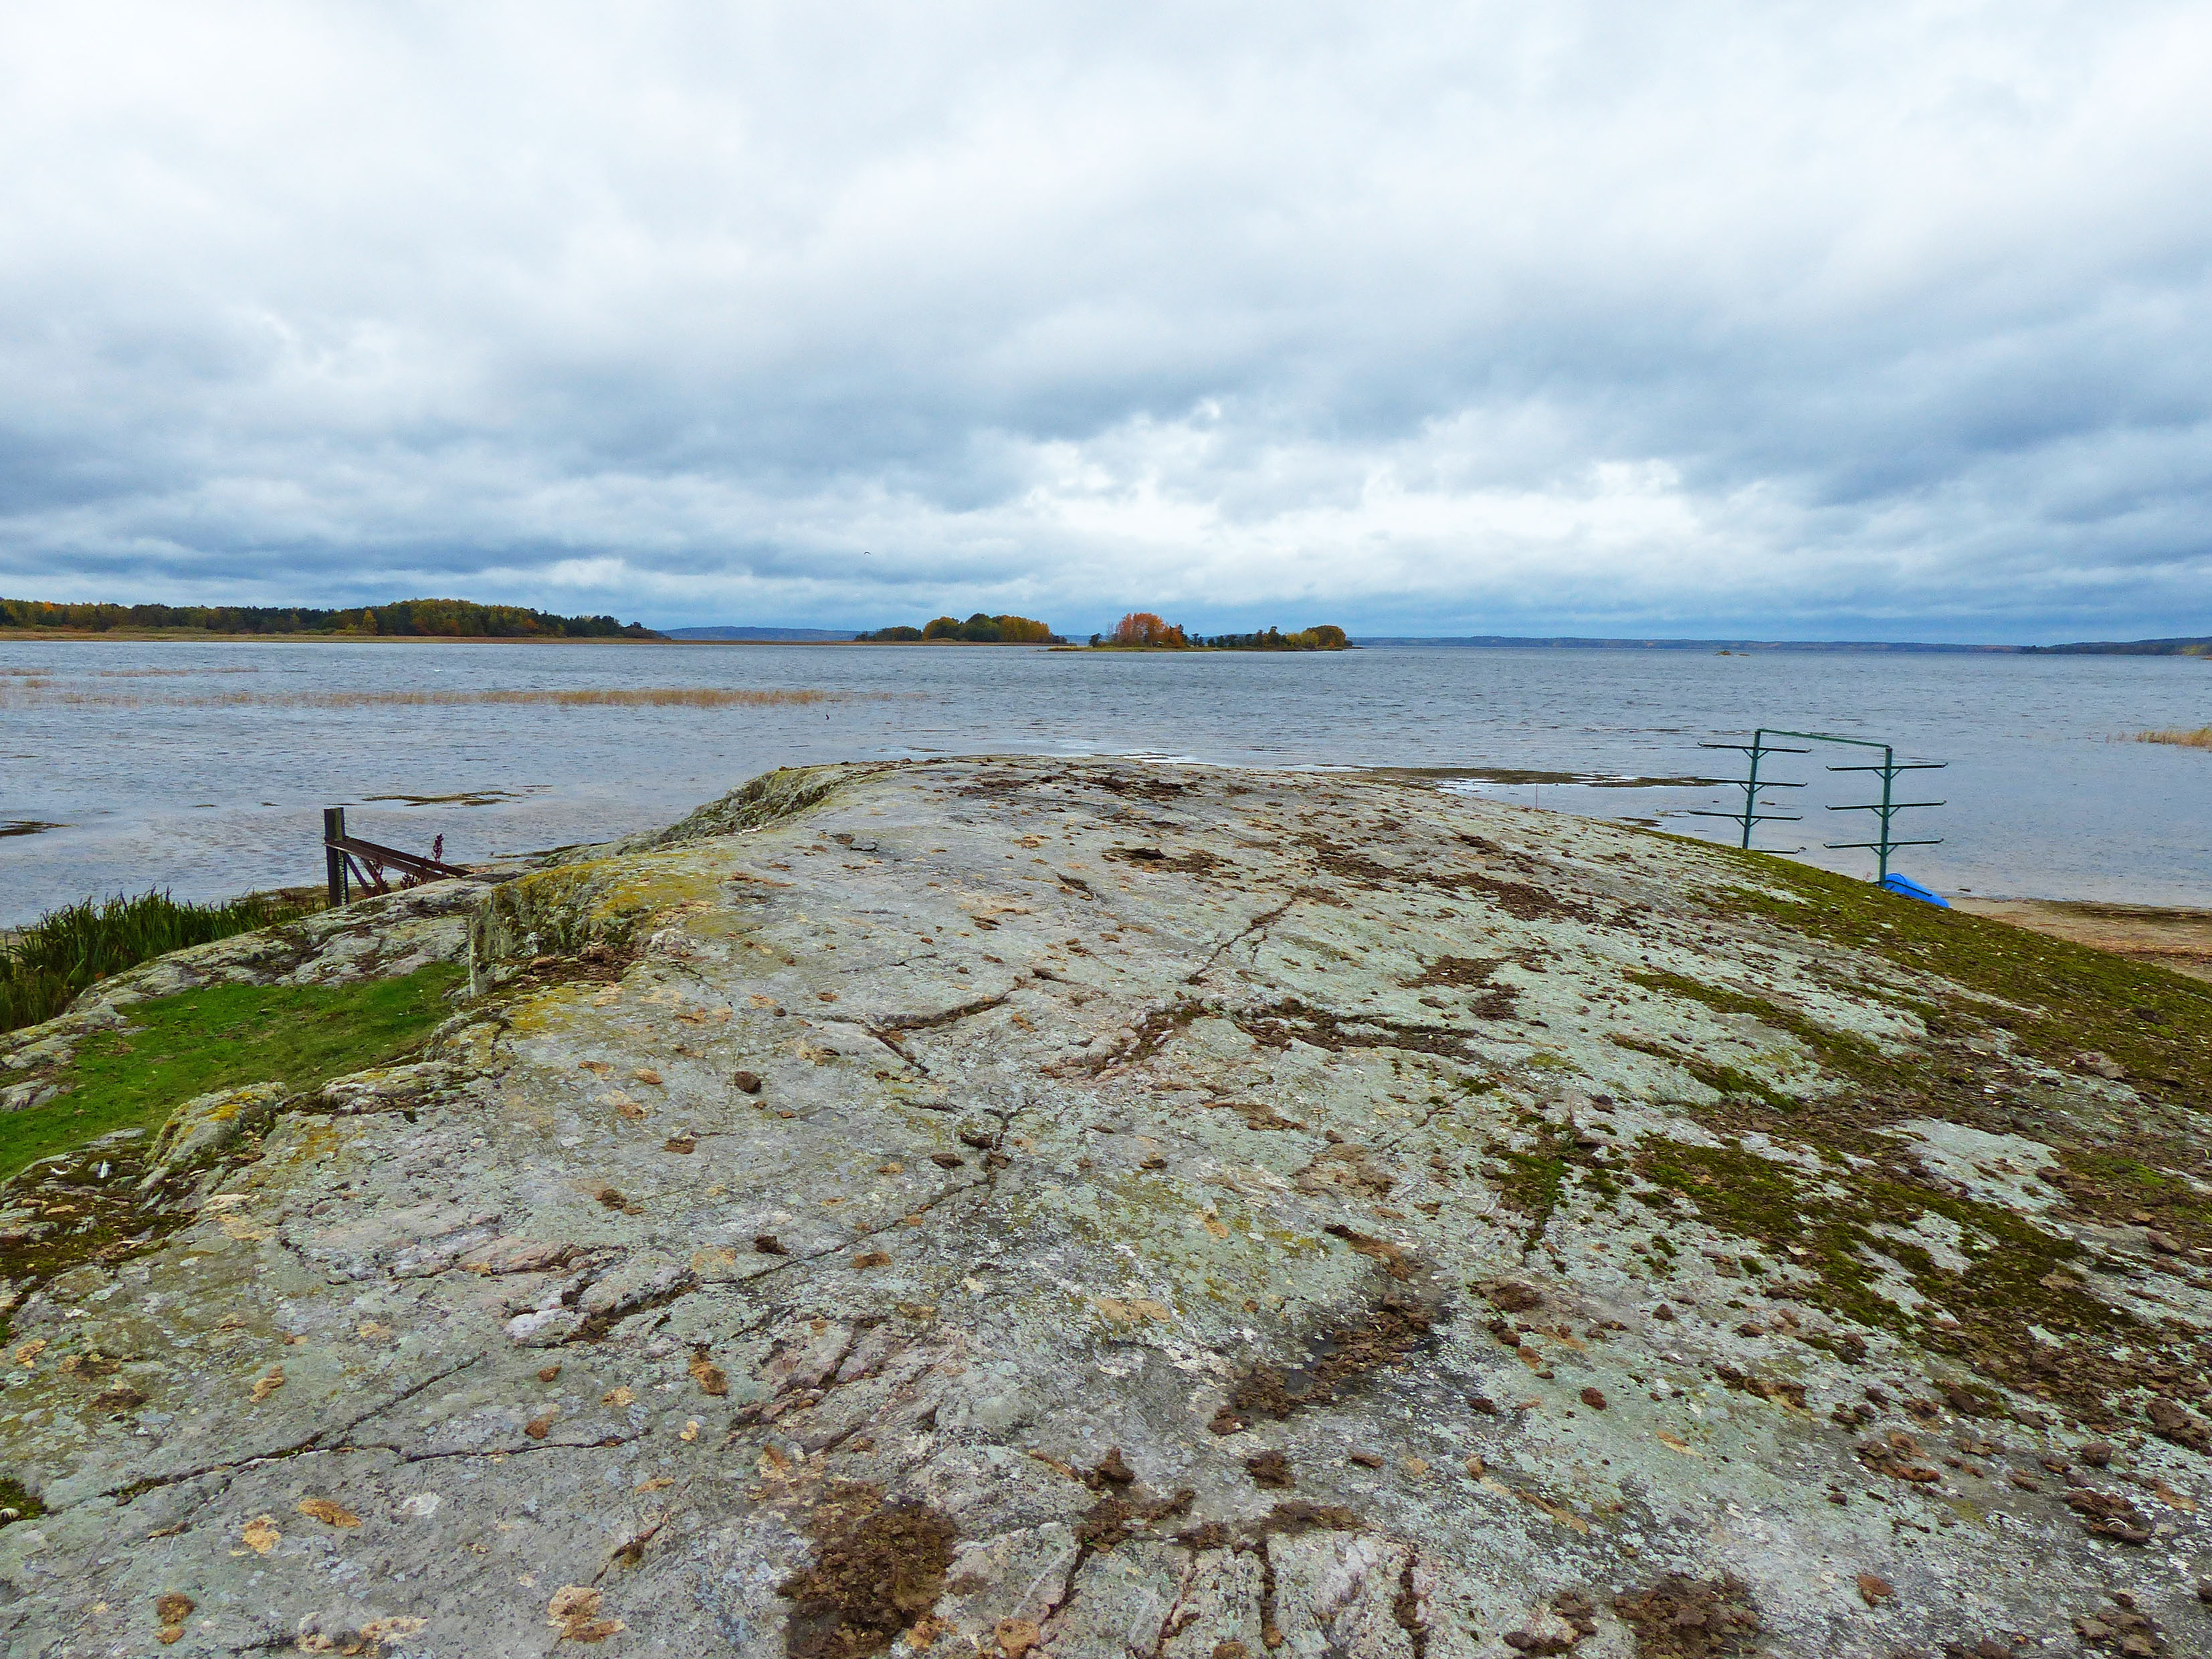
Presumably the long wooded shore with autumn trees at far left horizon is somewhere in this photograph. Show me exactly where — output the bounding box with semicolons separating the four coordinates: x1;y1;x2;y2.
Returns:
0;599;662;640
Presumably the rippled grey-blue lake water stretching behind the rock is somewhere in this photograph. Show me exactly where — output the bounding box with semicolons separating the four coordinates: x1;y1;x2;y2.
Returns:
0;640;2212;924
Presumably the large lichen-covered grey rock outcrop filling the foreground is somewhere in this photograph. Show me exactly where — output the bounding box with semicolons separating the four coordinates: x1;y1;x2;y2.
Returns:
0;759;2212;1659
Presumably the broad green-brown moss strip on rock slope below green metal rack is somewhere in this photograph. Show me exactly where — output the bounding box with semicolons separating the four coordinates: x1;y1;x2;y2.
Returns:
1706;852;2212;1108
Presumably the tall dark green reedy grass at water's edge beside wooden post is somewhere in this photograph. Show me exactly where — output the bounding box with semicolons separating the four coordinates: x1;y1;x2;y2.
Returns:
0;892;316;1031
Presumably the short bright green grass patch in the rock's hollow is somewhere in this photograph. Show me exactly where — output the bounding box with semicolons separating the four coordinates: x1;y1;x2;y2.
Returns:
0;962;462;1179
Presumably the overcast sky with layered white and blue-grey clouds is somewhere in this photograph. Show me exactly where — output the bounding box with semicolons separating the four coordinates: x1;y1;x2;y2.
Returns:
0;0;2212;642
